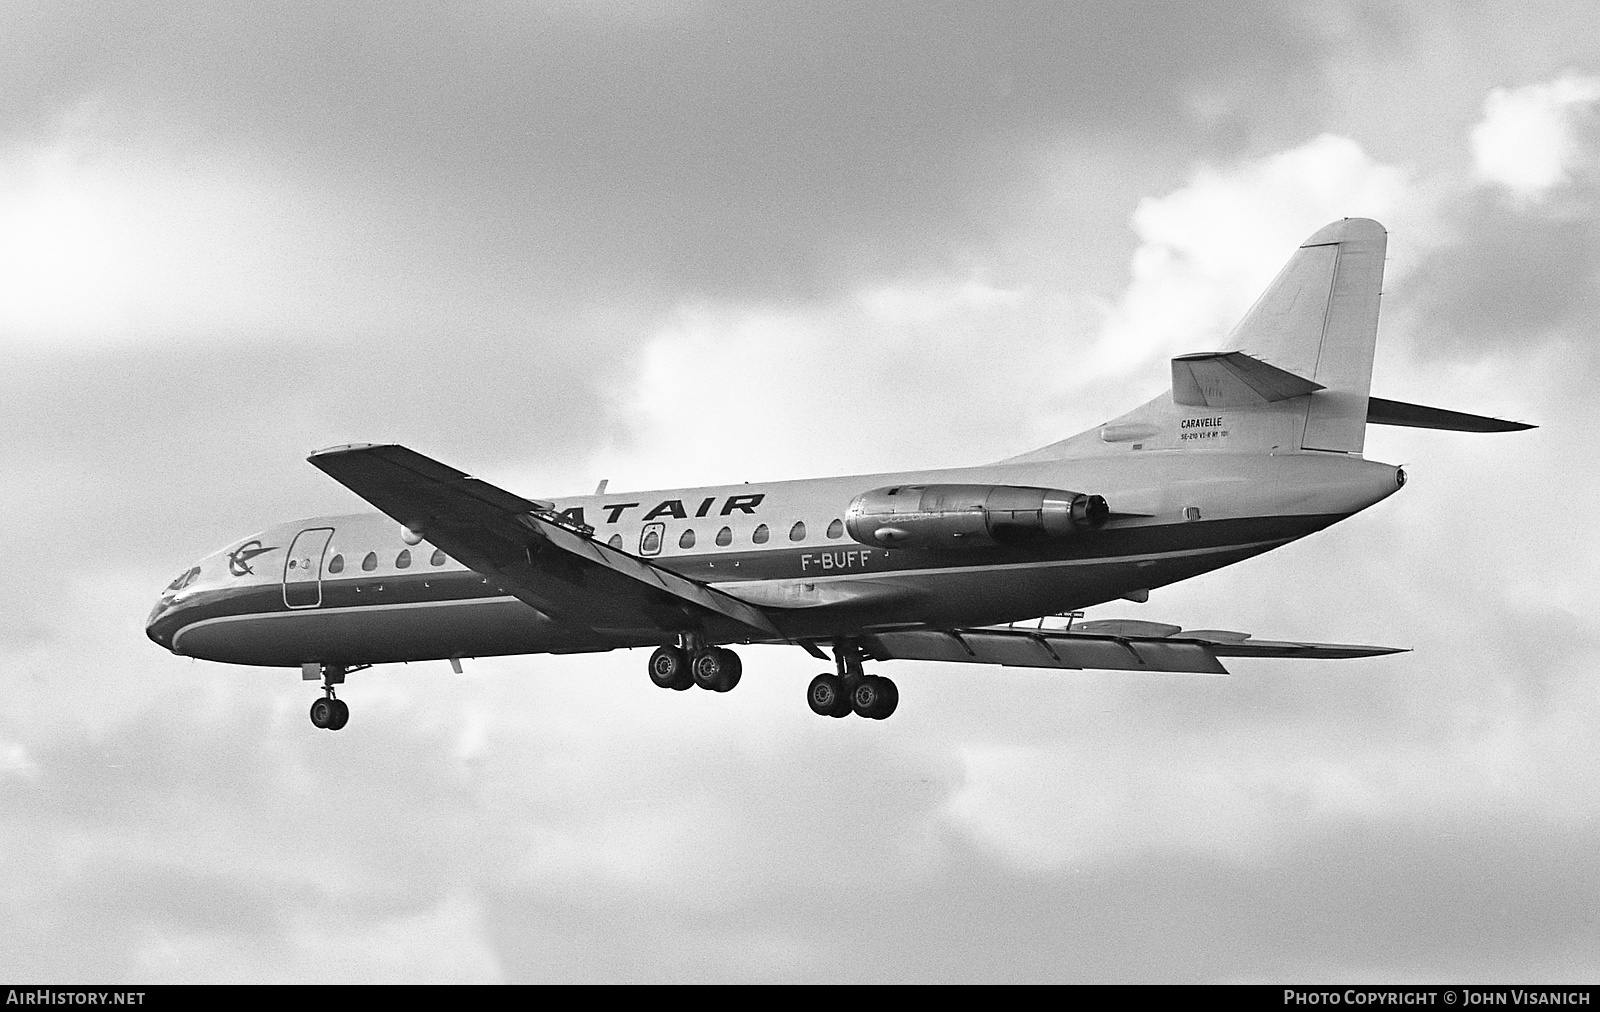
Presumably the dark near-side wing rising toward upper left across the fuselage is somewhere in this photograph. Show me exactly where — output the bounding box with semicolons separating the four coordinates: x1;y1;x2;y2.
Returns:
307;444;784;642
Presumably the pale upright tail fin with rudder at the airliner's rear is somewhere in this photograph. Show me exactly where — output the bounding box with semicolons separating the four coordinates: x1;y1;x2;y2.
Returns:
1227;218;1389;453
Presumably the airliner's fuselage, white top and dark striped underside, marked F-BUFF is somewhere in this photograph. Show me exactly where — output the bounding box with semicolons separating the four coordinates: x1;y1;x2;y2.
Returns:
149;450;1403;666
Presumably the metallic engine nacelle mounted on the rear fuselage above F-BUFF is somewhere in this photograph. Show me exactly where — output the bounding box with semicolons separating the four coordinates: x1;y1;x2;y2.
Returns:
845;485;1110;548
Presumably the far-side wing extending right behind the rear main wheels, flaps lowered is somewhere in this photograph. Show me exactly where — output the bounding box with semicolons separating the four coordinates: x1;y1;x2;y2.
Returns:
862;620;1405;674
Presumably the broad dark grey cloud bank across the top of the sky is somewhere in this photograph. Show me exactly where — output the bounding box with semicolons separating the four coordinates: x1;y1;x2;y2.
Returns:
0;3;1314;309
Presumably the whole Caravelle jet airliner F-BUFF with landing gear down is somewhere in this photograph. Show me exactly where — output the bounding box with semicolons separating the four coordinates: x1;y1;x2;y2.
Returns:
147;218;1533;730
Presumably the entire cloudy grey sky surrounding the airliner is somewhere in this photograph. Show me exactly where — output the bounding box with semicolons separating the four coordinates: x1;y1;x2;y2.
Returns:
0;0;1600;982
